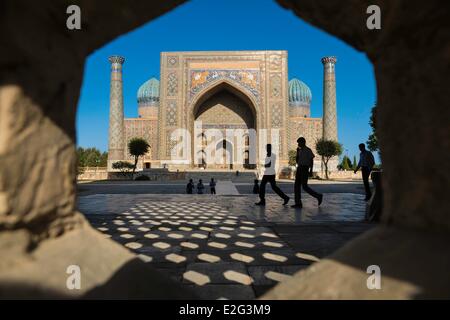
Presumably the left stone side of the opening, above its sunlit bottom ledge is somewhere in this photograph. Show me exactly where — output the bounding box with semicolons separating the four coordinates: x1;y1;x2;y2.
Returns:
0;0;183;234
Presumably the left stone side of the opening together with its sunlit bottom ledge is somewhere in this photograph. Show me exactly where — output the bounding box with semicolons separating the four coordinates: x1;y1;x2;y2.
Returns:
0;0;191;298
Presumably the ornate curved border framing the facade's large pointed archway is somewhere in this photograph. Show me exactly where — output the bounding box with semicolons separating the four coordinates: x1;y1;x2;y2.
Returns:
186;79;262;166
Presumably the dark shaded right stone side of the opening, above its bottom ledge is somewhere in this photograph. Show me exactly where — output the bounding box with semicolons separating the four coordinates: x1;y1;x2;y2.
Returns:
278;0;450;232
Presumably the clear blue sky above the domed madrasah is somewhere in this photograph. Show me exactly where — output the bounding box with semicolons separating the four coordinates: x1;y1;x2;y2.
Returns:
77;0;376;161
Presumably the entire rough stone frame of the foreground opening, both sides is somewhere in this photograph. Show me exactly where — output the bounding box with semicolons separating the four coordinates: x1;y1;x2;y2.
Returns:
0;0;450;299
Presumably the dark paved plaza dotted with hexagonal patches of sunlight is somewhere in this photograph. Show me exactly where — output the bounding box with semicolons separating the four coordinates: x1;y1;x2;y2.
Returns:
78;182;372;299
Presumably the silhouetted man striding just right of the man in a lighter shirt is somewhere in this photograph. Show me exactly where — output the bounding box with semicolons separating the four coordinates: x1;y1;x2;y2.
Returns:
292;137;323;208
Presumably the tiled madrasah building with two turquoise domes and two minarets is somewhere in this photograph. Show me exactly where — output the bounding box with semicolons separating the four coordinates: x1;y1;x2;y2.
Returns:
108;51;337;171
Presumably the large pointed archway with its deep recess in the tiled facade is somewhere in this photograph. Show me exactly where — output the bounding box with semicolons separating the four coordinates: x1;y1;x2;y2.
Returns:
190;80;258;170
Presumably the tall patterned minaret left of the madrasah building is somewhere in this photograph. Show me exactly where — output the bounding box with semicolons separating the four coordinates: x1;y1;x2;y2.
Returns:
108;56;125;170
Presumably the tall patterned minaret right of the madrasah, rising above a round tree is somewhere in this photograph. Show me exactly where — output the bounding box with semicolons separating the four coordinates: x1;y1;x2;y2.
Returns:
322;57;337;141
